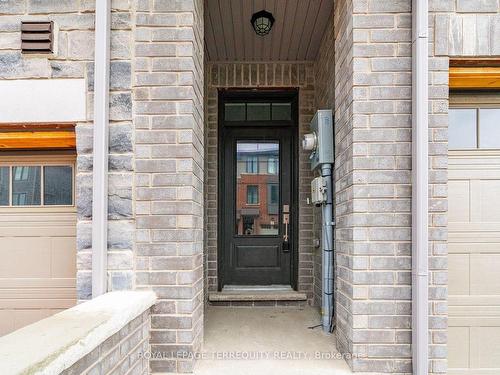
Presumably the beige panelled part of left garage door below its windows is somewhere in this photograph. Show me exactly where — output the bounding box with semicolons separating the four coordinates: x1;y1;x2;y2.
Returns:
0;207;76;335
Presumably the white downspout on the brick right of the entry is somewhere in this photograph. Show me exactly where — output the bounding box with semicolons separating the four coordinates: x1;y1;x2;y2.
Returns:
412;0;429;375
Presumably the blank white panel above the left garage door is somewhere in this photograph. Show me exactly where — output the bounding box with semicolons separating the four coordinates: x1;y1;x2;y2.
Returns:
0;79;86;123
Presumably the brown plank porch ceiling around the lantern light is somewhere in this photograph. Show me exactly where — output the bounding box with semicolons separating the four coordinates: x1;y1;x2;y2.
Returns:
205;0;333;61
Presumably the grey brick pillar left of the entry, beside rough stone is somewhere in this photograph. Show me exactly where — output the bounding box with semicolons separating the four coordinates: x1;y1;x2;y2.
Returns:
133;0;204;373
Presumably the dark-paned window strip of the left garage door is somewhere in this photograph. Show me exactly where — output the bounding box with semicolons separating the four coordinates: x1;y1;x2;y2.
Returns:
0;164;74;207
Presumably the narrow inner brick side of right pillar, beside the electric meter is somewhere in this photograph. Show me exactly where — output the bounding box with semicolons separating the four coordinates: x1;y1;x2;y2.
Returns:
334;0;354;367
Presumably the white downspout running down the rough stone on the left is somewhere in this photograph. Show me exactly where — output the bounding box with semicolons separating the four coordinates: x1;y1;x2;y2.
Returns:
92;0;111;298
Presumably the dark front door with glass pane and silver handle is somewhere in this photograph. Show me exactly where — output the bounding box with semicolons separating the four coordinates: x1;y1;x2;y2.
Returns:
219;91;296;285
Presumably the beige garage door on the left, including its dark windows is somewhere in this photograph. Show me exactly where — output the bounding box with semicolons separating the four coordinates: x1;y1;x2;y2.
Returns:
0;155;76;335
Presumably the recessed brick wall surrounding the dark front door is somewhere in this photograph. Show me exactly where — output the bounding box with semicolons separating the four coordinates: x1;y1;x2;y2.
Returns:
205;62;315;304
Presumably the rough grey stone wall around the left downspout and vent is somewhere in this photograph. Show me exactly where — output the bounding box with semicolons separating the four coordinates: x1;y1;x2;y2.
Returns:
0;0;134;300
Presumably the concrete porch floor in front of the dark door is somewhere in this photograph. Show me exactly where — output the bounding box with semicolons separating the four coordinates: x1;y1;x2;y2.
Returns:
194;307;352;375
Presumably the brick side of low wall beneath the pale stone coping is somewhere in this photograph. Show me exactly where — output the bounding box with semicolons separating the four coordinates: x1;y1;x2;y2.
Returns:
61;310;151;375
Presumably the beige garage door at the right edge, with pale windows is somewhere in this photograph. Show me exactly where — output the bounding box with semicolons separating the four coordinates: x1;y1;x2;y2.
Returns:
448;96;500;375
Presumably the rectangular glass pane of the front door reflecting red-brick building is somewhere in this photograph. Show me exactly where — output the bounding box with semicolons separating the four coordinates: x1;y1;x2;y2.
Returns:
236;142;280;236
